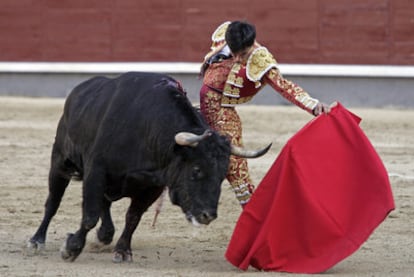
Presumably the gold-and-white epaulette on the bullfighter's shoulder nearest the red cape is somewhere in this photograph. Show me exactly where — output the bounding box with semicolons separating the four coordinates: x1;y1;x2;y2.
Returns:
246;46;277;82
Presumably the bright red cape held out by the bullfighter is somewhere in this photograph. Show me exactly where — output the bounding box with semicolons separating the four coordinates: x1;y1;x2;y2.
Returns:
225;104;394;273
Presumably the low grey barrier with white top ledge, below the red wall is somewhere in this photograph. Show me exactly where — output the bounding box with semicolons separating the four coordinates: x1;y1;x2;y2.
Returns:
0;62;414;108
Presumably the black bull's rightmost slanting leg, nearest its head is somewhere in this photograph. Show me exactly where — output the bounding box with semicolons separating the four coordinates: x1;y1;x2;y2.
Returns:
112;187;164;263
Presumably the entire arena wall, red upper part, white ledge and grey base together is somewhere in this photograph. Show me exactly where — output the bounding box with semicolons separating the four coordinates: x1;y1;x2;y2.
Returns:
0;0;414;107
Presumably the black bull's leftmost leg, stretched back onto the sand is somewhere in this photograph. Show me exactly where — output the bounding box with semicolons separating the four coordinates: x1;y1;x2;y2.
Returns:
28;156;70;252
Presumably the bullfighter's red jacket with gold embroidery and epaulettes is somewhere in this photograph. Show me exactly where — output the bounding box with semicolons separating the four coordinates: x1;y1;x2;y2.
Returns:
203;22;319;112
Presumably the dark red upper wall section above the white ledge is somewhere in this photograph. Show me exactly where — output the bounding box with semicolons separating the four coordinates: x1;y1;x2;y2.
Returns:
0;0;414;65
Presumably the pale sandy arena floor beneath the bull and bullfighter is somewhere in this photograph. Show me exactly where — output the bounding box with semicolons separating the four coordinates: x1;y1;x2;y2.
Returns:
0;97;414;277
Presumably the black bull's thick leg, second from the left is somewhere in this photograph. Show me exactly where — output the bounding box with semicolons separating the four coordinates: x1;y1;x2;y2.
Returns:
60;172;105;262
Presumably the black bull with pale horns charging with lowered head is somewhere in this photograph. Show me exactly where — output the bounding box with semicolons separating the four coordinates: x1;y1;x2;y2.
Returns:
29;72;268;261
